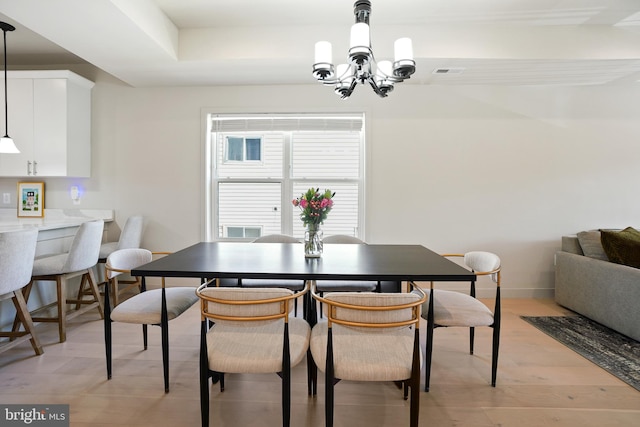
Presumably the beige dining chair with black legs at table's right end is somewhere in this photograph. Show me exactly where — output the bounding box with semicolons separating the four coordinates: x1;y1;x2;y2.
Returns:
422;251;501;391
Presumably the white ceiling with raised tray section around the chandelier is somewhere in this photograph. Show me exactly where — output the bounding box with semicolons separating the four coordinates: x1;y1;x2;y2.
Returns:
0;0;640;87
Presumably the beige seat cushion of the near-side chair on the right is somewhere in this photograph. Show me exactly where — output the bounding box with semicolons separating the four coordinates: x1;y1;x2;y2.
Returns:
311;321;422;381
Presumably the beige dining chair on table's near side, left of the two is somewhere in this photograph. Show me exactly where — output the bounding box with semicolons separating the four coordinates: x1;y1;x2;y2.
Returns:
197;284;310;427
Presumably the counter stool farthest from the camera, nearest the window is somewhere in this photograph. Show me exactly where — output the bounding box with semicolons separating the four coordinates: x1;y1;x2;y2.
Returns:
98;215;144;307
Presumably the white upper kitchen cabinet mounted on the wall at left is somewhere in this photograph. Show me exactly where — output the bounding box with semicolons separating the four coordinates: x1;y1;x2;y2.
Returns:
0;70;93;178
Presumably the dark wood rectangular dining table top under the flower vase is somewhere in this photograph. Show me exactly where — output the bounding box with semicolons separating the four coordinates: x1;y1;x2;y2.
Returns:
132;242;475;282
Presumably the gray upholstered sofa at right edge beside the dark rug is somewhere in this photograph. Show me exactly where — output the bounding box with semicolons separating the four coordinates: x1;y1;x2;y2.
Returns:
555;236;640;341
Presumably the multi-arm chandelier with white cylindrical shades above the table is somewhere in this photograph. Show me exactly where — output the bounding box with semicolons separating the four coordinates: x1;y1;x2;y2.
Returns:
313;0;416;99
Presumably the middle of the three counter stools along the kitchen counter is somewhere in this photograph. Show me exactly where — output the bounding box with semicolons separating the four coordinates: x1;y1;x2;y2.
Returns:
25;219;104;342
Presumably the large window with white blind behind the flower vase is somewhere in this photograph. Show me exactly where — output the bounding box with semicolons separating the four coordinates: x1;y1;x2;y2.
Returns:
205;114;364;240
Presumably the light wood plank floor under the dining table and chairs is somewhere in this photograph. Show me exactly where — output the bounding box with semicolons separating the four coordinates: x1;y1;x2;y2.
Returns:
0;299;640;427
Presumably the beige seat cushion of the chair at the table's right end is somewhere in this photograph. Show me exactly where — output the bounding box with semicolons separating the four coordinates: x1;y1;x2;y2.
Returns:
422;289;493;327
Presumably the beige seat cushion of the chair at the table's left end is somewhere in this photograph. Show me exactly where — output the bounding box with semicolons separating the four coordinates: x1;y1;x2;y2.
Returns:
111;287;198;325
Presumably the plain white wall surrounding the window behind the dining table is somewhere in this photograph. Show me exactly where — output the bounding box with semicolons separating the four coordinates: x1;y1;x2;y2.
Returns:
0;70;640;297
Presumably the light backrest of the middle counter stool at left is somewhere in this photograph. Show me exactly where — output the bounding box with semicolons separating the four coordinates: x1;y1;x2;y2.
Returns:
63;219;104;273
